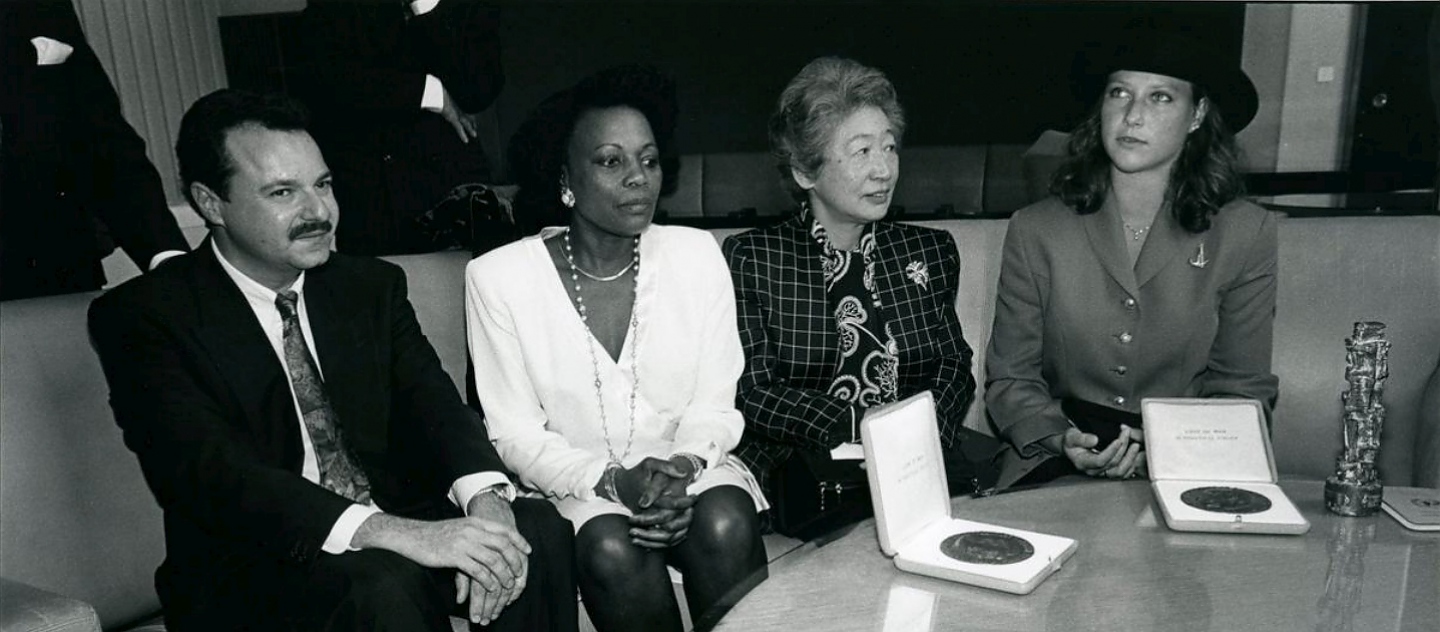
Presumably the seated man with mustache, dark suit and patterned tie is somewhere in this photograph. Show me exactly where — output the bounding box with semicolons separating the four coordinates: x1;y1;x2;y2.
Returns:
89;91;576;632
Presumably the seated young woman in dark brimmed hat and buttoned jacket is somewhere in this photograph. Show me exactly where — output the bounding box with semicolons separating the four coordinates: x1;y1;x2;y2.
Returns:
985;32;1279;485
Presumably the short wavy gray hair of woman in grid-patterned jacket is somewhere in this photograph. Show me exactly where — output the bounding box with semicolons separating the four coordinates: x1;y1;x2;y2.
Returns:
769;58;904;202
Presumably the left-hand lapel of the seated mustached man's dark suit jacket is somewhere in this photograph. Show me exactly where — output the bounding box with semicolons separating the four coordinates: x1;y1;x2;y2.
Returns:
193;240;304;472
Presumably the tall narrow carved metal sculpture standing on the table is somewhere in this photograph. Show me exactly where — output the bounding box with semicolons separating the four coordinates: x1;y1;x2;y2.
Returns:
1325;321;1390;515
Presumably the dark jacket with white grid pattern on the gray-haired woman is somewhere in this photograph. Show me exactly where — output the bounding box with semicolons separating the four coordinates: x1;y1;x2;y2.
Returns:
723;213;975;495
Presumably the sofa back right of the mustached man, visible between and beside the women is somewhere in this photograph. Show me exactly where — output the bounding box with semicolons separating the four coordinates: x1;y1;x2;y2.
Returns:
389;216;1440;487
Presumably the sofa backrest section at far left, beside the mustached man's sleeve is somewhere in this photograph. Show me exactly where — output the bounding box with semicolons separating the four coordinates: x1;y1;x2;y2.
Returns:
0;292;164;628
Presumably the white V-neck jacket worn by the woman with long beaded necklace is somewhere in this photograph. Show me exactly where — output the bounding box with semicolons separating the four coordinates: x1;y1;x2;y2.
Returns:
465;226;744;501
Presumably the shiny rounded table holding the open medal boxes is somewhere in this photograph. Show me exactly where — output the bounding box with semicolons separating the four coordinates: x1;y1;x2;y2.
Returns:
717;481;1440;632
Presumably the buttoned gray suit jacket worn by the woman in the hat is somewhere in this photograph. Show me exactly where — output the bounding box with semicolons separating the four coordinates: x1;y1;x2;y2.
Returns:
985;197;1277;484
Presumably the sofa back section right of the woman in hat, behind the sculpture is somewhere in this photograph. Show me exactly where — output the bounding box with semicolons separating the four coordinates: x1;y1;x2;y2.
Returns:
1272;216;1440;487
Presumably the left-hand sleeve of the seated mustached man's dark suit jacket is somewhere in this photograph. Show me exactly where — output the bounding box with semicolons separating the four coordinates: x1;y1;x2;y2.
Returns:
89;288;350;561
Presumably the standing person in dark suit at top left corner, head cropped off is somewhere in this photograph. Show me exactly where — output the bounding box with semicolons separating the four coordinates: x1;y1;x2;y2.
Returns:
0;0;190;299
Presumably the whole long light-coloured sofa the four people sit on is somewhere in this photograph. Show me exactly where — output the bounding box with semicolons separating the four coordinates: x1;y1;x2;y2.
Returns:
0;216;1440;632
